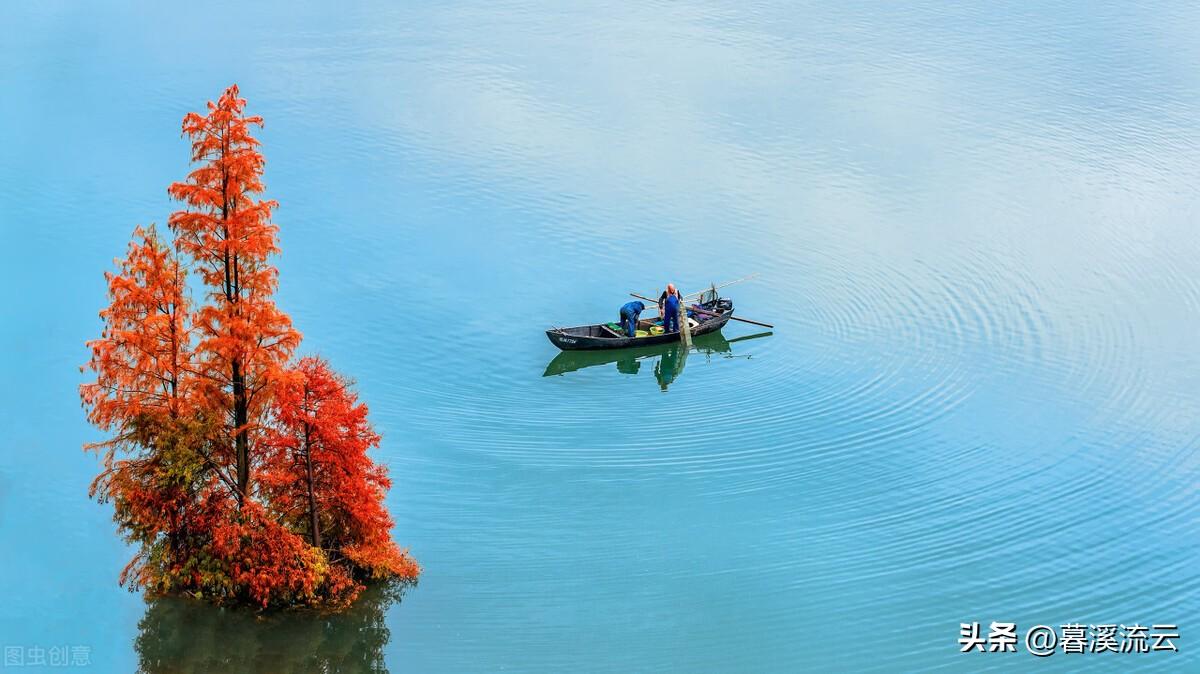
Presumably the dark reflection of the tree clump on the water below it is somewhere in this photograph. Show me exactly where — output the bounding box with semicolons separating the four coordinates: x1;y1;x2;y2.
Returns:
134;584;407;674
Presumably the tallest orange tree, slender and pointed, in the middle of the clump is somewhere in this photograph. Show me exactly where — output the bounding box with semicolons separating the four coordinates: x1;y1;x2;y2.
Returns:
168;85;300;505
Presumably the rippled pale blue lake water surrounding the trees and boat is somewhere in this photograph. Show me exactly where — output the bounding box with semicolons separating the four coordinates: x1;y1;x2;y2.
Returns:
0;1;1200;672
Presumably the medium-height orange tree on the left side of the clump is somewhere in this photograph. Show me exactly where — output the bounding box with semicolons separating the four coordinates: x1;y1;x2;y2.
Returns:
80;225;212;583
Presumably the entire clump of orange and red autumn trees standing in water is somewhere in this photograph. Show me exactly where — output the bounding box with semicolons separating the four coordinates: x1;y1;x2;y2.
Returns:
80;85;419;607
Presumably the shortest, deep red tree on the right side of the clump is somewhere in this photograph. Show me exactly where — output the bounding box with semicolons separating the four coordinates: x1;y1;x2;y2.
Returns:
262;356;419;578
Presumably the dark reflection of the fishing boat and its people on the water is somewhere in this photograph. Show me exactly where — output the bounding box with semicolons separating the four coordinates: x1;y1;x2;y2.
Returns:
542;332;773;391
